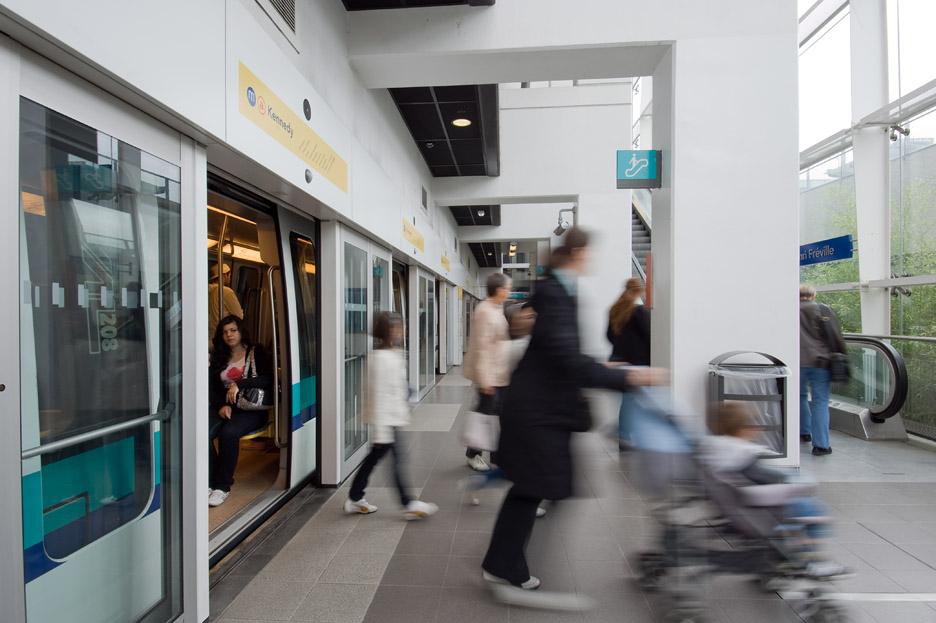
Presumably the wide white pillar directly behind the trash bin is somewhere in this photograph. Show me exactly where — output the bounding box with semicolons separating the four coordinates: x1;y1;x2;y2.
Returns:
651;25;799;465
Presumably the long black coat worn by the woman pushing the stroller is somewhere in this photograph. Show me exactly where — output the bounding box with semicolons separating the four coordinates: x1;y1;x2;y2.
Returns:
497;276;629;500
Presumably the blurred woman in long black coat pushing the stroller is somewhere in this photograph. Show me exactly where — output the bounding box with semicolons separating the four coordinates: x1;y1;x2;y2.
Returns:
481;227;666;589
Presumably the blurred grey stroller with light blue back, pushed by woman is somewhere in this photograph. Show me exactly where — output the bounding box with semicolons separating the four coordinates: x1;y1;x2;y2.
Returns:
631;387;846;623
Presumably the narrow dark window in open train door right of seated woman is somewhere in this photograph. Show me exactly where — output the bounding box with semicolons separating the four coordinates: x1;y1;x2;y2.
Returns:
290;234;318;424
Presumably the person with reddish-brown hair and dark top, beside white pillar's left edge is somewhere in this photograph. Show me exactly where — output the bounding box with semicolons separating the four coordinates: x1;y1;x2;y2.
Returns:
608;277;650;450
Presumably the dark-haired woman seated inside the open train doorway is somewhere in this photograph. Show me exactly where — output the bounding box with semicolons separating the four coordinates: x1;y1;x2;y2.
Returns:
208;315;274;506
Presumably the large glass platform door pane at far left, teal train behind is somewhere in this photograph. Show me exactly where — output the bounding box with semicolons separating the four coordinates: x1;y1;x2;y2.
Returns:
20;98;182;600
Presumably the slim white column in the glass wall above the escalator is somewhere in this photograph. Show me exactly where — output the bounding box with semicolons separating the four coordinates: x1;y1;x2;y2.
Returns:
850;0;891;335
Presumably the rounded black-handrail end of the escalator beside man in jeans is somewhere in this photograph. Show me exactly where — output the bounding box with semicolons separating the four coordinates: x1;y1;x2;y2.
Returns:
829;333;909;440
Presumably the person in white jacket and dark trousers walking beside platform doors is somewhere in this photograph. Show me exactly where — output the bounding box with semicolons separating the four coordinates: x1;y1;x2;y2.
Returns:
344;312;439;520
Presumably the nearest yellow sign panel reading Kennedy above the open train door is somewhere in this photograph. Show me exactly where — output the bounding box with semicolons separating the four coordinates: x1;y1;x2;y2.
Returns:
238;63;348;193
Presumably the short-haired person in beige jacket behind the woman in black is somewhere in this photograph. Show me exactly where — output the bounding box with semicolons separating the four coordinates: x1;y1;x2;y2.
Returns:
463;273;511;472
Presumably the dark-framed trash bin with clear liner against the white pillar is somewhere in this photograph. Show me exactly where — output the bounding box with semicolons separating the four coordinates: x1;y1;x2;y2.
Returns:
708;350;790;458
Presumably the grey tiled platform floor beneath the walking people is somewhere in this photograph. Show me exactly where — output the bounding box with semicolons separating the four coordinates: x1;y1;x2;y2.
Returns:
211;371;936;623
